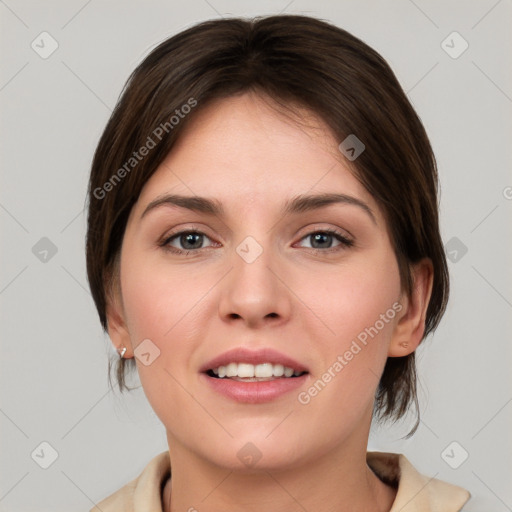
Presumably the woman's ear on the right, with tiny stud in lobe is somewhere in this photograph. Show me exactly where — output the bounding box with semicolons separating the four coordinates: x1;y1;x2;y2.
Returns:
388;258;434;357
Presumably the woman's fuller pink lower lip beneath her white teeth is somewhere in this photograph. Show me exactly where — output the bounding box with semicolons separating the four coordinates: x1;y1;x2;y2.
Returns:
201;373;309;404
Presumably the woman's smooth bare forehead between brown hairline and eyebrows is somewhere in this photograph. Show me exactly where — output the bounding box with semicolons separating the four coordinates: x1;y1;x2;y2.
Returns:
130;93;379;224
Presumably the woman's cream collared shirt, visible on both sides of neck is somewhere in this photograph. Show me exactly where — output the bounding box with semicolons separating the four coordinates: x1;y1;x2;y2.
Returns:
89;451;471;512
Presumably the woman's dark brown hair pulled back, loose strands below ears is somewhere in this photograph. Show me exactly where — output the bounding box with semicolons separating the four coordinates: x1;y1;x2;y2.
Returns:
86;15;449;436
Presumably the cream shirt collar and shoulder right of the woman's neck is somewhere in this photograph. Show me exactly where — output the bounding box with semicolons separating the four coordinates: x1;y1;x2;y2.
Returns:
366;452;471;512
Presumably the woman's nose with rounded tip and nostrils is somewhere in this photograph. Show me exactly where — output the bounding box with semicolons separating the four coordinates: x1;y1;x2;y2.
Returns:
219;239;292;328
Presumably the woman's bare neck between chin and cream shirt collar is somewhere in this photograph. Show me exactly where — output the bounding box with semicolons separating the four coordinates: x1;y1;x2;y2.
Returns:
162;428;396;512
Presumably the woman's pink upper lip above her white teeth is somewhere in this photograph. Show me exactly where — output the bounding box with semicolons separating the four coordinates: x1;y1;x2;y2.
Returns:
200;347;308;372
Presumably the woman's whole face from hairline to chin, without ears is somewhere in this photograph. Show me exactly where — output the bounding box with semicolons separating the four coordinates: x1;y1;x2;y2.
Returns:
113;94;404;468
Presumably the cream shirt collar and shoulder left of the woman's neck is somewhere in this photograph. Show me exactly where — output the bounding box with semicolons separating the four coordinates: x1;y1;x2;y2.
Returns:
89;451;170;512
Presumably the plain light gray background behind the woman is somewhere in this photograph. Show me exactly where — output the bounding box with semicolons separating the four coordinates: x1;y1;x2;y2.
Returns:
0;0;512;512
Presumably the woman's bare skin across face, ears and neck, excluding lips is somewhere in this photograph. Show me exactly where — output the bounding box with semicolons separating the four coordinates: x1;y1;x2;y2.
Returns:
107;93;432;512
